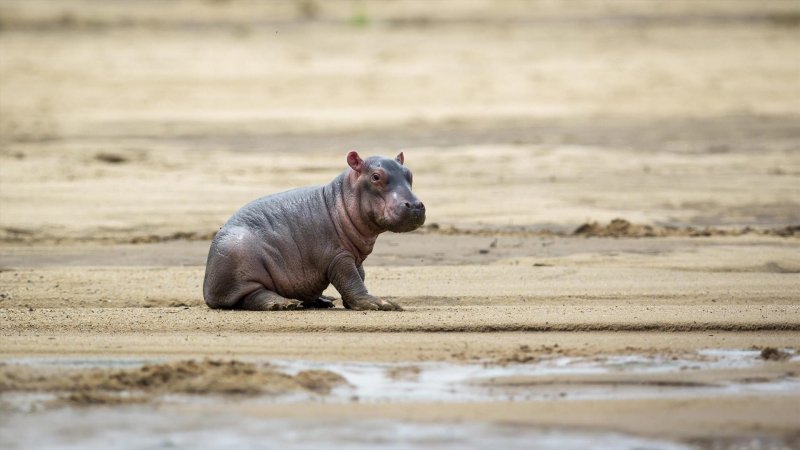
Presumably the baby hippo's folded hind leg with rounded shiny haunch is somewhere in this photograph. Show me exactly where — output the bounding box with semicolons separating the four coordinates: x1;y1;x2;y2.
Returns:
203;227;303;311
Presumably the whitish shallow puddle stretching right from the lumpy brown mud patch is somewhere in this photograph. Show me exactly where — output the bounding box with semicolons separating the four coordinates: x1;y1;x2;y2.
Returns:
266;350;800;403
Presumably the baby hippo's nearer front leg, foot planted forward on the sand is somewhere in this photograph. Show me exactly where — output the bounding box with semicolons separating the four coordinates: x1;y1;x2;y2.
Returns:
328;255;403;311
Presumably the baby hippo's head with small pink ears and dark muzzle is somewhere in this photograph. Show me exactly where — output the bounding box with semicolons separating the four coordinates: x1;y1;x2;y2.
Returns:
347;152;425;233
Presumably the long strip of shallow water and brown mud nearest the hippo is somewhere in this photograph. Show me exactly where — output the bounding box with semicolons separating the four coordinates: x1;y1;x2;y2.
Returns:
0;349;800;411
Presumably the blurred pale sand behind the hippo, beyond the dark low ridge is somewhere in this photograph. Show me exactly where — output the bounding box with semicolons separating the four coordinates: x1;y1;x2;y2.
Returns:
0;0;800;242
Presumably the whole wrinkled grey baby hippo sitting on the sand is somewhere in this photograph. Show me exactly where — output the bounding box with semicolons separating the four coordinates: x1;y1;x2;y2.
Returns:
203;152;425;310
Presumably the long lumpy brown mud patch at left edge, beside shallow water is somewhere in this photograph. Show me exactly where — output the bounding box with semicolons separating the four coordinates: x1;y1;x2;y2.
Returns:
0;360;347;404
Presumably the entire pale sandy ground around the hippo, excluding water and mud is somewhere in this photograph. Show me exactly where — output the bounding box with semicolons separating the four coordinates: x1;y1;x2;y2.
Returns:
0;0;800;448
